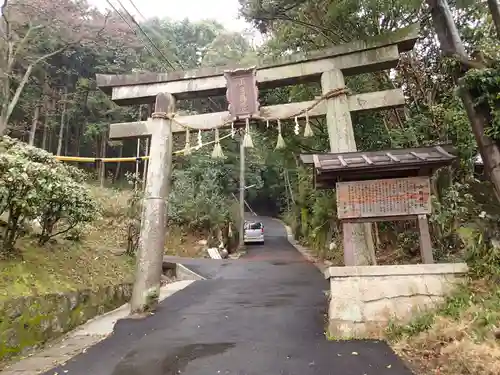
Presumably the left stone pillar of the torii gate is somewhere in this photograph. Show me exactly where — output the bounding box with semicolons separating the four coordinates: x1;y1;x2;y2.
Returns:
130;93;175;314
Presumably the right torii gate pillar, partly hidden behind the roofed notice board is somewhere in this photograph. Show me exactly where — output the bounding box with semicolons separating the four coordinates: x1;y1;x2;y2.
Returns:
321;69;376;266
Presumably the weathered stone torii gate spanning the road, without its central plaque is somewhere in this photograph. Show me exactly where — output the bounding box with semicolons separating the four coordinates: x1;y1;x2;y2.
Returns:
97;25;419;311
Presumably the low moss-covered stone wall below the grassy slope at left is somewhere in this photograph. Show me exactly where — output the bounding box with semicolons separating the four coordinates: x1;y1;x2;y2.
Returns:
0;284;132;360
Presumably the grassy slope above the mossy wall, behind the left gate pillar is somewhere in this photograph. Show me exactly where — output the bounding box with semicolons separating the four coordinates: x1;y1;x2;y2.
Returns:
0;186;206;301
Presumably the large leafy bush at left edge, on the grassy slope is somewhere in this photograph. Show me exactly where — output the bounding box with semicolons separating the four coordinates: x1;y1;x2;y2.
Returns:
0;137;99;252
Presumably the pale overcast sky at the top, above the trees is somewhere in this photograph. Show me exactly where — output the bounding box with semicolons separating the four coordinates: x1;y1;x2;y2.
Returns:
88;0;250;31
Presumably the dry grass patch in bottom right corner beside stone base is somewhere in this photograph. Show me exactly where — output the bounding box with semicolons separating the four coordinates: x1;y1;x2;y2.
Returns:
393;283;500;375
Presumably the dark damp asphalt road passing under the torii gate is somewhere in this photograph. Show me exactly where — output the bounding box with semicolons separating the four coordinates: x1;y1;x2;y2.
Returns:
45;218;411;375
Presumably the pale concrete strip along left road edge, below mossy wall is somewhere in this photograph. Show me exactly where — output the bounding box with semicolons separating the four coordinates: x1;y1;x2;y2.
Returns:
0;280;198;375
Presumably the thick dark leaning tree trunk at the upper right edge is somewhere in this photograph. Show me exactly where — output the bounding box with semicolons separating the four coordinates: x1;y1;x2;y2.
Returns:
427;0;500;199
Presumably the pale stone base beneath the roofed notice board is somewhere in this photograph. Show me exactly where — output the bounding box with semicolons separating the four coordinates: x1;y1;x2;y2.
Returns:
325;263;468;339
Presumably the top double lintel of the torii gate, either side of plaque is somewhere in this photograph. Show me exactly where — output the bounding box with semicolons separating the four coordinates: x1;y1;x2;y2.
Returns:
96;24;419;105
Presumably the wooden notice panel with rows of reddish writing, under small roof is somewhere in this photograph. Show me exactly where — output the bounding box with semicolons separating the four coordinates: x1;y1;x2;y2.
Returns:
337;177;431;221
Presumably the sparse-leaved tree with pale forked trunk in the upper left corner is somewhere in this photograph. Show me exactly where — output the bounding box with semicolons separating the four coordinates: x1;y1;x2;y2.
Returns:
0;0;115;135
